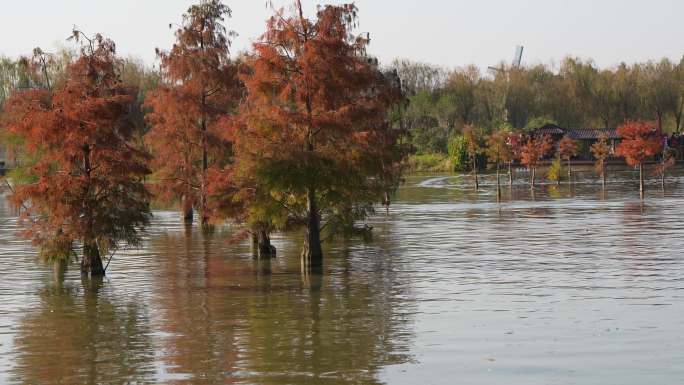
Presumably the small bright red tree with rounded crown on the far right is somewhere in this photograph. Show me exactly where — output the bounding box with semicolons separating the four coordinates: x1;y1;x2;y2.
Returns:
615;121;662;199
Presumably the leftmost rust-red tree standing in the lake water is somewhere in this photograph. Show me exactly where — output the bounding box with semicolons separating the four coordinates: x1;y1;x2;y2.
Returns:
7;31;150;275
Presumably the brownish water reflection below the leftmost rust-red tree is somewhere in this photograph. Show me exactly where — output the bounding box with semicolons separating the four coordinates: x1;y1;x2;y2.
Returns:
13;267;154;384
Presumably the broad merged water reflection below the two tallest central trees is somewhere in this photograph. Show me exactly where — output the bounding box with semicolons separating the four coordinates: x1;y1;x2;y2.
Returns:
153;222;412;384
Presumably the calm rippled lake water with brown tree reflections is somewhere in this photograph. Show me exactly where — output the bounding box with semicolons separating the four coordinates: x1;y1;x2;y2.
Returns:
0;172;684;385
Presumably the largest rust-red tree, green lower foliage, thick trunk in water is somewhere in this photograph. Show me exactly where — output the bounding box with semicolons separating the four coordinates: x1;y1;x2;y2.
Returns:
235;1;403;268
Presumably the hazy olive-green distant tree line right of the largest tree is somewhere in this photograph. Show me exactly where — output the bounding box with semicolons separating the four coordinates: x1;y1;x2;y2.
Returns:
392;57;684;154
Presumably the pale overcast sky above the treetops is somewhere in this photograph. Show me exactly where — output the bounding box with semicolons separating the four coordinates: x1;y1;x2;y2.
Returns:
0;0;684;67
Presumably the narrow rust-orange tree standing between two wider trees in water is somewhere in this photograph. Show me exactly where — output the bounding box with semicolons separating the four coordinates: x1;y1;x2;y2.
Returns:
145;0;243;226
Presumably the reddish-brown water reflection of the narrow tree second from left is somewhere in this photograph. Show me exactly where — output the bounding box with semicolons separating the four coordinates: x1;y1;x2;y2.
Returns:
152;231;239;384
